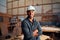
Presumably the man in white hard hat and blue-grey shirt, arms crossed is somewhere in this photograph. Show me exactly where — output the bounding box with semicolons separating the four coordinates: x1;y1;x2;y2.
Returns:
21;6;42;40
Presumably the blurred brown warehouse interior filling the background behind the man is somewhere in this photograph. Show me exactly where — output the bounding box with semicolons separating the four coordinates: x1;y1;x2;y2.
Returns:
0;0;60;40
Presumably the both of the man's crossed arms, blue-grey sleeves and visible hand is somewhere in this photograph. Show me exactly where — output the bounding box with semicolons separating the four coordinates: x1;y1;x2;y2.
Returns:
22;22;42;38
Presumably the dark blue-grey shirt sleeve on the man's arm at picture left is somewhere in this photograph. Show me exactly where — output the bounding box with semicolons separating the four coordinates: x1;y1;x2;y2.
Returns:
21;22;33;39
